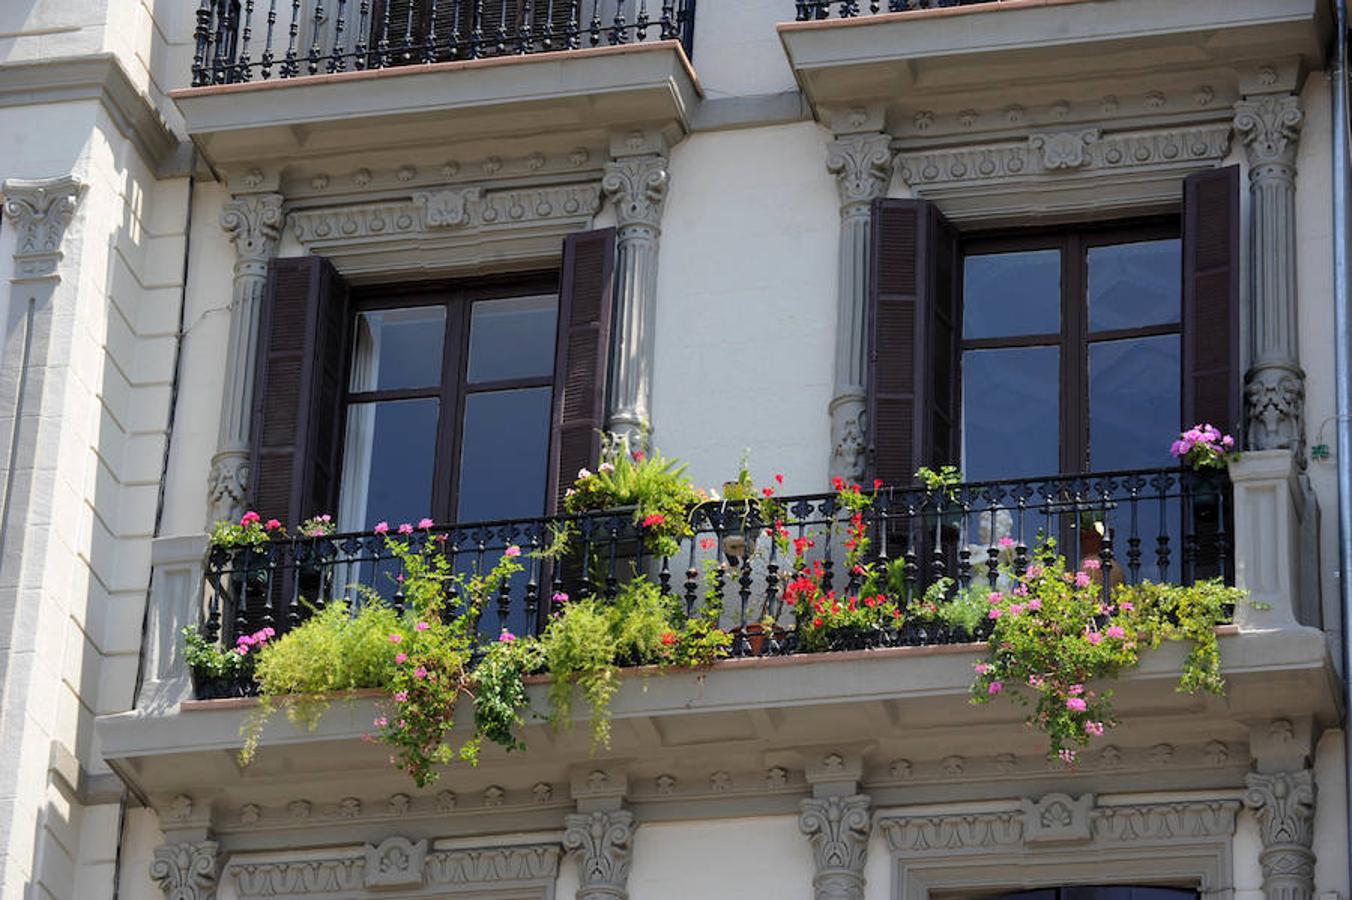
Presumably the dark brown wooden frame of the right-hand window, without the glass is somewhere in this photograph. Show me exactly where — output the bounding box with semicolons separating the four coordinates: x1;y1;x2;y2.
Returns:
956;215;1184;474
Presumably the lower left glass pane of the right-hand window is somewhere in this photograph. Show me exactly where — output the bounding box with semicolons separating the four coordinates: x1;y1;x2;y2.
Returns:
963;347;1061;481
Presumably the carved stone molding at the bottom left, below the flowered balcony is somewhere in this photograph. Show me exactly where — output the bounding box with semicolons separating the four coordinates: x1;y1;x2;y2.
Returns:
226;836;560;900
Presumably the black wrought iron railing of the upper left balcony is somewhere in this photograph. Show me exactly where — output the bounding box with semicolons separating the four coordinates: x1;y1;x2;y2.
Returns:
192;0;695;86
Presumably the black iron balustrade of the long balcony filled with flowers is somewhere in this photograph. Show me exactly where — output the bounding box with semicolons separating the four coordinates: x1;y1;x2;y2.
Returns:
193;469;1234;697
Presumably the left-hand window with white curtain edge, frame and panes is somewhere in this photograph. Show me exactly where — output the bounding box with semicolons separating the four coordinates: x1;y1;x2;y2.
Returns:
338;277;558;531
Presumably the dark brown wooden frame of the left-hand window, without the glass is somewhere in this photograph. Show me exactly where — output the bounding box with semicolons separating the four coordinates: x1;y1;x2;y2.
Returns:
338;270;561;523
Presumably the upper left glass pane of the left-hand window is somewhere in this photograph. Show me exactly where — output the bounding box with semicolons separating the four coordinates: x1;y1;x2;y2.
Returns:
349;307;446;393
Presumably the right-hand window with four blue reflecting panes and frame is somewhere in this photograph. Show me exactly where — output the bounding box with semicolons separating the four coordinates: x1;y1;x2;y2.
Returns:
961;223;1183;481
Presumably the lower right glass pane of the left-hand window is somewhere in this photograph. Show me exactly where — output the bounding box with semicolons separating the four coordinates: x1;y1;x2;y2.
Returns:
457;388;553;522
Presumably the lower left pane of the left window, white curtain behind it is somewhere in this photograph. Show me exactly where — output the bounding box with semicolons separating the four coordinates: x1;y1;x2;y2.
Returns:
338;399;439;531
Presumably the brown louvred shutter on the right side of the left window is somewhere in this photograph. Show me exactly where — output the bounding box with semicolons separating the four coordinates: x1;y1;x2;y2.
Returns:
548;228;615;514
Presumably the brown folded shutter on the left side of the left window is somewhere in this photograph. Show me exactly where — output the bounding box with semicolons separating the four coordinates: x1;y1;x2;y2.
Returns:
253;257;347;528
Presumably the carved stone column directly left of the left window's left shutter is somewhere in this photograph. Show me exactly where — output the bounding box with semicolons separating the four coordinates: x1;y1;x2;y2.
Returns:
207;193;283;527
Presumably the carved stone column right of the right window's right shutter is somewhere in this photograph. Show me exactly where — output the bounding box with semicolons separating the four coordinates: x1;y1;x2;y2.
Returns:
1234;95;1305;456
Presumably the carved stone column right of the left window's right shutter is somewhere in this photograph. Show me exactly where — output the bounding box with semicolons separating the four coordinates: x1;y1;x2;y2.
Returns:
600;132;669;447
